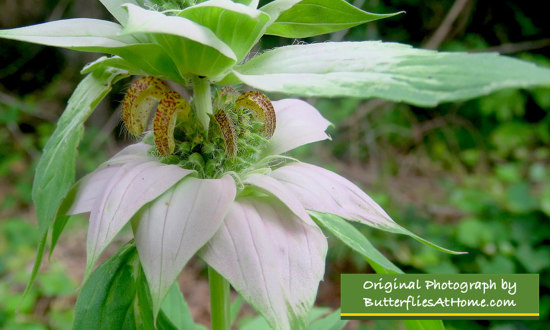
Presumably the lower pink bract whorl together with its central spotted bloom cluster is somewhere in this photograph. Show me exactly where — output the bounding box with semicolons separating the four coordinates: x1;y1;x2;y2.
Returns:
68;77;398;328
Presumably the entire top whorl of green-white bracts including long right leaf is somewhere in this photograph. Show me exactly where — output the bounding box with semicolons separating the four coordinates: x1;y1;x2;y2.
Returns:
0;0;550;98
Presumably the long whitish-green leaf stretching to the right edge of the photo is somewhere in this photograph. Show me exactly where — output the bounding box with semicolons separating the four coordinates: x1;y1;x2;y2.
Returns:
226;41;550;106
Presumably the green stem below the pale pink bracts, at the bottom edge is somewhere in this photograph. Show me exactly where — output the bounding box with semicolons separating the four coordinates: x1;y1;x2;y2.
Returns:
208;267;231;330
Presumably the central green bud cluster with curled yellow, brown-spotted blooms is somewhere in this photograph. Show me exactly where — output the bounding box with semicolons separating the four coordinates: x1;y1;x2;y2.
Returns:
123;77;276;178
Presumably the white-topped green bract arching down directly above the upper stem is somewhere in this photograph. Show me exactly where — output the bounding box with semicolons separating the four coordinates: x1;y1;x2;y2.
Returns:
123;4;237;77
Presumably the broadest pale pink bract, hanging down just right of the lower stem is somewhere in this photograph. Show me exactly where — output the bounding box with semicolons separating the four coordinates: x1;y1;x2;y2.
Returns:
200;198;327;329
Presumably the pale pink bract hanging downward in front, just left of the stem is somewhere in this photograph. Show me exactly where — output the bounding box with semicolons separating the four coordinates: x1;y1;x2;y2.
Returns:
132;176;236;315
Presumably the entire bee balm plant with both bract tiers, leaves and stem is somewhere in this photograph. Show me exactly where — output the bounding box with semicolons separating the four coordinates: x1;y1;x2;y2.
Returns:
0;0;550;330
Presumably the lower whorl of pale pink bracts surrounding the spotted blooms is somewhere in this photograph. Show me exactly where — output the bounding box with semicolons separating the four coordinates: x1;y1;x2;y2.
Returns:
69;89;406;328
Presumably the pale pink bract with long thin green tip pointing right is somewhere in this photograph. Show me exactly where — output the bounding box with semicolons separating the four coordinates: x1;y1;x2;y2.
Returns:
271;163;462;254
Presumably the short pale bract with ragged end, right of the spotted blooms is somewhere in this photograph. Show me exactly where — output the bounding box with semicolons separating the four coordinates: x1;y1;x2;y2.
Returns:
266;99;330;155
